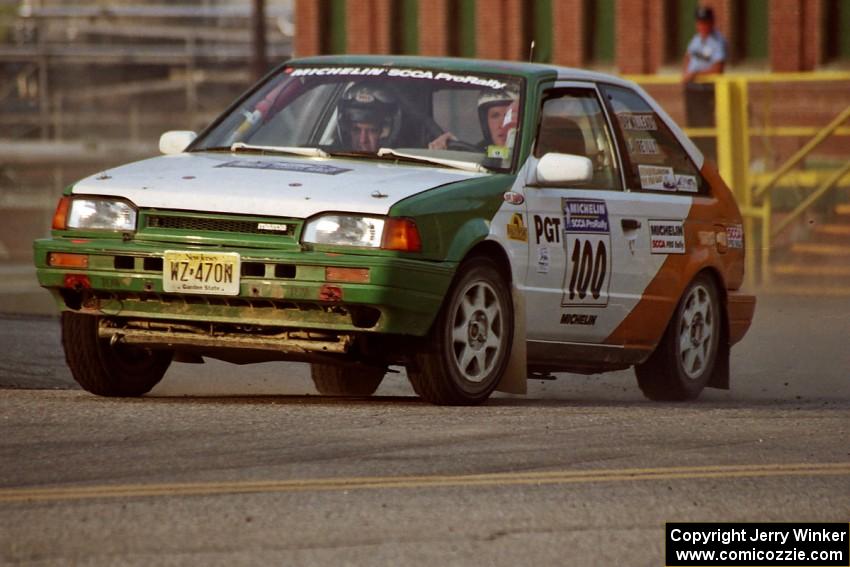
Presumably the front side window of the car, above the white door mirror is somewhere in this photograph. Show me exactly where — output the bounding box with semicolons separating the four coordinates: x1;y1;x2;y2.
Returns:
534;89;622;189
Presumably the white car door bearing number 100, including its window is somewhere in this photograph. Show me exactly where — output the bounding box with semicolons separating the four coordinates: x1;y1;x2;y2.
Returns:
524;83;653;344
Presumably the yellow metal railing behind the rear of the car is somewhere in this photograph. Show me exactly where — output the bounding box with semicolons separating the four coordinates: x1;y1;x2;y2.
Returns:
629;71;850;286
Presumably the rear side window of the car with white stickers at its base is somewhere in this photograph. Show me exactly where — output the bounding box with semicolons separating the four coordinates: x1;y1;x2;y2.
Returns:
601;85;708;193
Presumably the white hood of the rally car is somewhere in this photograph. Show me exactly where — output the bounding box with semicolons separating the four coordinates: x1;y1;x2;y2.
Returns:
73;153;485;218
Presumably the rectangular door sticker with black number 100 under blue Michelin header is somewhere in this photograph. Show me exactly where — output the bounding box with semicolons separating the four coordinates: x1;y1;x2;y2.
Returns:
561;199;611;307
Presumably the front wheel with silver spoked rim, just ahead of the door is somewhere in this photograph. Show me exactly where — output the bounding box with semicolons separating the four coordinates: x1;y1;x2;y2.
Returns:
407;257;514;405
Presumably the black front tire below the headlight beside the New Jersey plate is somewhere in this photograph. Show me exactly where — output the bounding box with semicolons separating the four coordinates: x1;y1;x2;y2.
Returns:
62;312;172;397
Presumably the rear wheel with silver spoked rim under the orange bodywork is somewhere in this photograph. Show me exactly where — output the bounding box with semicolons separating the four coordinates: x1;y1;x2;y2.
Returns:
635;274;723;401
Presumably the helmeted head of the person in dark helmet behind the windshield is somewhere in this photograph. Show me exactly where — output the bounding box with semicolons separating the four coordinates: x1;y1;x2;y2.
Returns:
337;83;401;153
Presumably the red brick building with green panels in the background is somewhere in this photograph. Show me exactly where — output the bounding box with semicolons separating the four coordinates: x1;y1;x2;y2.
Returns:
295;0;850;74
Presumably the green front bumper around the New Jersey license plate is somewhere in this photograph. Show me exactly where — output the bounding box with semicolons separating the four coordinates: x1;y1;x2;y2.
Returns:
34;238;456;336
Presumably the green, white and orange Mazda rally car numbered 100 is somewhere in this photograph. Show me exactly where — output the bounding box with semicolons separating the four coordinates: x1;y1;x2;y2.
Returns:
34;56;755;404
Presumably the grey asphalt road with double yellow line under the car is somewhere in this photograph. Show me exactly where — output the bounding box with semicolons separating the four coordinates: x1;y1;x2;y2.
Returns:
0;296;850;566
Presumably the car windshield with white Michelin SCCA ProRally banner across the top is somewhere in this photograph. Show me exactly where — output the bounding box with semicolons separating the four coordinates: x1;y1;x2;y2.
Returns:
191;66;522;171
